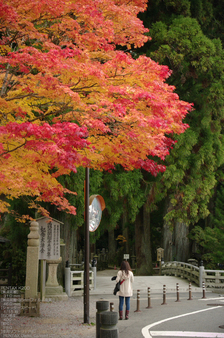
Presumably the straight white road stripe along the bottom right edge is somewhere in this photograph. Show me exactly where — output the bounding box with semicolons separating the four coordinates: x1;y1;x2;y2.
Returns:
150;331;224;338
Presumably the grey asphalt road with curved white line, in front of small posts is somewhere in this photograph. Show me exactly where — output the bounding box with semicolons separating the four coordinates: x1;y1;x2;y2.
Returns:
94;292;224;338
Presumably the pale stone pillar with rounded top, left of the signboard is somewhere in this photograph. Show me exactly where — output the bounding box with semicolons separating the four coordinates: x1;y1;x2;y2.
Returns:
25;221;40;299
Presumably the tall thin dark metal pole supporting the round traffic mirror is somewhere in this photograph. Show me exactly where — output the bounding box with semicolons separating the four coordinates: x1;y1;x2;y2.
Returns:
84;168;89;324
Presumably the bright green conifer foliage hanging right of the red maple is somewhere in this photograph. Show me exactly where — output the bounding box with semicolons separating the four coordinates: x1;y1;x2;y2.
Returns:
139;0;224;225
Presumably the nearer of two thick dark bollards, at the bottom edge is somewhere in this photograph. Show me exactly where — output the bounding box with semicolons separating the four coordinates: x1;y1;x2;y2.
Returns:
100;312;118;338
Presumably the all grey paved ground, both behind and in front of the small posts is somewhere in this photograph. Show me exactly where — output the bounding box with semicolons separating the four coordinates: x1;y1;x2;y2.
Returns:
91;270;224;338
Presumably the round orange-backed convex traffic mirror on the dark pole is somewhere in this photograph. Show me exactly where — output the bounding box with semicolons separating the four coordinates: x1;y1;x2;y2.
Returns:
89;195;105;232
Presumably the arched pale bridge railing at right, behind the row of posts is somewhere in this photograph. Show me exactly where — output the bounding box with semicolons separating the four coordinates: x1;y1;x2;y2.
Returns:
162;261;224;288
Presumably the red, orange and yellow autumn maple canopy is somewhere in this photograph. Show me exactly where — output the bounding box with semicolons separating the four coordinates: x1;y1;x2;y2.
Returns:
0;0;191;218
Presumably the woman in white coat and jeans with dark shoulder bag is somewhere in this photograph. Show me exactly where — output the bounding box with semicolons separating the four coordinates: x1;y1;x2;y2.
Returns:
116;261;134;320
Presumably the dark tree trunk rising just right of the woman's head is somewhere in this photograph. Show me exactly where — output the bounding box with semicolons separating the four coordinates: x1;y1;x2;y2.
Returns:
135;203;153;276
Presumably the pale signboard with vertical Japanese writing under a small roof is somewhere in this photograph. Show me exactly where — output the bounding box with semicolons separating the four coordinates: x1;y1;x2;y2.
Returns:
37;217;61;260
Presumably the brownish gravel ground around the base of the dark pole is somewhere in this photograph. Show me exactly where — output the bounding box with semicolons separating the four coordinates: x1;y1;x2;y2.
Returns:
3;297;96;338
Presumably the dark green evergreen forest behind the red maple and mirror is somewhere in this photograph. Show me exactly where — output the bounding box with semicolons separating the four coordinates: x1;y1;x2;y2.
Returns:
0;0;224;283
